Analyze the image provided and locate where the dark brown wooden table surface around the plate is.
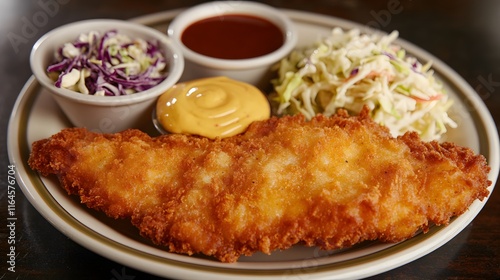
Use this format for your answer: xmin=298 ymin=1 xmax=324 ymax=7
xmin=0 ymin=0 xmax=500 ymax=279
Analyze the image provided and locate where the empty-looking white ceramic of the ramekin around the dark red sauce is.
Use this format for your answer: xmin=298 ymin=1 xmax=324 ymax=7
xmin=167 ymin=1 xmax=298 ymax=88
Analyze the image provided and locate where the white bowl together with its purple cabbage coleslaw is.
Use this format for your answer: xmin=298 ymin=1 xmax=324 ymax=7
xmin=30 ymin=19 xmax=184 ymax=133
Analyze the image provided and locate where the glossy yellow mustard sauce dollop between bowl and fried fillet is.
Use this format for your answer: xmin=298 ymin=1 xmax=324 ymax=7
xmin=156 ymin=77 xmax=271 ymax=139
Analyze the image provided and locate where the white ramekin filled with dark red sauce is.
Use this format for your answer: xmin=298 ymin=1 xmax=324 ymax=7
xmin=167 ymin=1 xmax=297 ymax=88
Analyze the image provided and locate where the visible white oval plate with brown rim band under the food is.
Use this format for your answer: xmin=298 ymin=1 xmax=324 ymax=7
xmin=8 ymin=10 xmax=500 ymax=279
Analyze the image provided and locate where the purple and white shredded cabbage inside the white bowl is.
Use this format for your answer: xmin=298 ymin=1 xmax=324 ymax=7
xmin=47 ymin=30 xmax=168 ymax=96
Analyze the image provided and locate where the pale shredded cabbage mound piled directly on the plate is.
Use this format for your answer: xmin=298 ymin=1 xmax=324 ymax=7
xmin=272 ymin=28 xmax=457 ymax=141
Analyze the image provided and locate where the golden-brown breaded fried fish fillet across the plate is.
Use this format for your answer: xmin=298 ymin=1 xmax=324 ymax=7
xmin=29 ymin=110 xmax=491 ymax=262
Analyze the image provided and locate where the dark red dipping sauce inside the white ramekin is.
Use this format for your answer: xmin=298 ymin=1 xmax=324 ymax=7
xmin=181 ymin=14 xmax=284 ymax=59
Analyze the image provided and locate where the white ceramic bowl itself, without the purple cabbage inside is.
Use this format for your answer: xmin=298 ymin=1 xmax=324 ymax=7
xmin=30 ymin=19 xmax=184 ymax=133
